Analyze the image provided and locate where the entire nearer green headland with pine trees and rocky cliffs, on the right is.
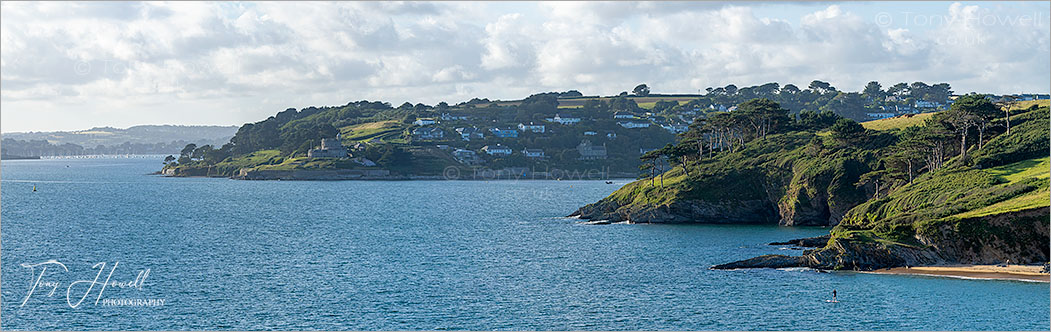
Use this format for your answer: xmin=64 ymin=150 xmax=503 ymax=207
xmin=574 ymin=96 xmax=1051 ymax=269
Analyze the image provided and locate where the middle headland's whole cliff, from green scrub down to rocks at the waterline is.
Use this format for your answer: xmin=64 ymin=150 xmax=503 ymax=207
xmin=571 ymin=134 xmax=873 ymax=226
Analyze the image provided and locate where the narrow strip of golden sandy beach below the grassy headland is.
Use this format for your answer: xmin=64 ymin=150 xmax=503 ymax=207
xmin=872 ymin=265 xmax=1051 ymax=283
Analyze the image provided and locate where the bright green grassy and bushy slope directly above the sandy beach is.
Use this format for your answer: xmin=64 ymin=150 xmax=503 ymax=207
xmin=832 ymin=107 xmax=1051 ymax=243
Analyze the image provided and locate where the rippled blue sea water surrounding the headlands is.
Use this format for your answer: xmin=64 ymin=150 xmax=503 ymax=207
xmin=0 ymin=159 xmax=1051 ymax=330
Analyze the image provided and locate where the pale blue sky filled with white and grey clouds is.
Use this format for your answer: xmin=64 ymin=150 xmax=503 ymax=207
xmin=0 ymin=1 xmax=1051 ymax=132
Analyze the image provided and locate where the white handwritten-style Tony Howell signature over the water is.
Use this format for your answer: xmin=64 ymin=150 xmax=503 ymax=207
xmin=19 ymin=260 xmax=149 ymax=309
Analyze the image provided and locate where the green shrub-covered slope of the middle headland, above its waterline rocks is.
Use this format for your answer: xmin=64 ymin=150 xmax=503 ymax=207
xmin=592 ymin=131 xmax=874 ymax=220
